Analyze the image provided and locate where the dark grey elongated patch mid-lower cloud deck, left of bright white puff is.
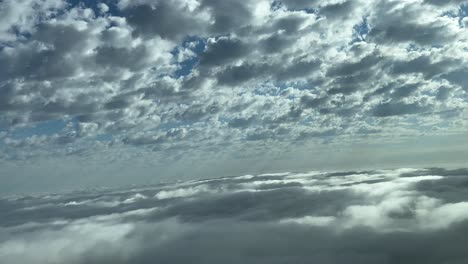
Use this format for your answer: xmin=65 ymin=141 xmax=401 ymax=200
xmin=154 ymin=188 xmax=359 ymax=222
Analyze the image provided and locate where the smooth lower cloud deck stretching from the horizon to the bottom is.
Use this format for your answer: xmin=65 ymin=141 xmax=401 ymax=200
xmin=0 ymin=168 xmax=468 ymax=264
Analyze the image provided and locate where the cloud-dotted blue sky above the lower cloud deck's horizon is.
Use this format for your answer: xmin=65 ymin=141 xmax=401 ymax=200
xmin=0 ymin=0 xmax=468 ymax=193
